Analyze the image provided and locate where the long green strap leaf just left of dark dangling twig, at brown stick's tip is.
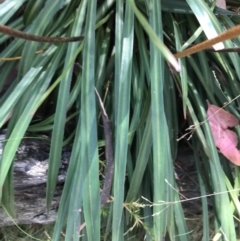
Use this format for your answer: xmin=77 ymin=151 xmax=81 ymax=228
xmin=80 ymin=0 xmax=100 ymax=241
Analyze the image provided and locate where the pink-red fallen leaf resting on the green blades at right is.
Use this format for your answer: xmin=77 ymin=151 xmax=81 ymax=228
xmin=207 ymin=102 xmax=240 ymax=166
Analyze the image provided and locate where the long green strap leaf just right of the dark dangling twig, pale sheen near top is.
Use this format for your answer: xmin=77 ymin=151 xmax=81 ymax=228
xmin=112 ymin=2 xmax=134 ymax=241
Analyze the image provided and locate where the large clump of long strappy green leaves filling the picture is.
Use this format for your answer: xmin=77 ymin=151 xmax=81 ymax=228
xmin=0 ymin=0 xmax=240 ymax=241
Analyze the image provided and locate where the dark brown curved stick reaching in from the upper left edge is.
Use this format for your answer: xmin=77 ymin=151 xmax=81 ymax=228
xmin=0 ymin=25 xmax=84 ymax=43
